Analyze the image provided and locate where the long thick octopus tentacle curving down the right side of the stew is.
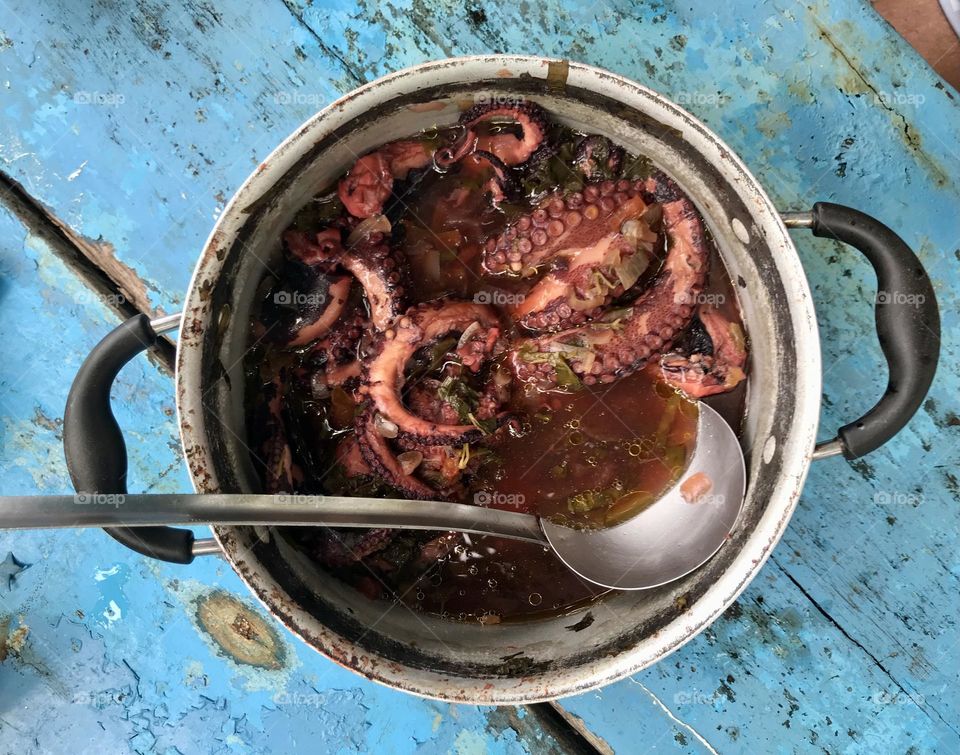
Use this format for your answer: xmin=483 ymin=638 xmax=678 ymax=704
xmin=511 ymin=193 xmax=709 ymax=390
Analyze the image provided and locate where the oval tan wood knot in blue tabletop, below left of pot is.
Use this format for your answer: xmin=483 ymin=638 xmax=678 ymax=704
xmin=196 ymin=592 xmax=286 ymax=670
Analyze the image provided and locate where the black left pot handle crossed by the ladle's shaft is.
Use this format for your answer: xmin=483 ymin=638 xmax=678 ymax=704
xmin=63 ymin=314 xmax=219 ymax=564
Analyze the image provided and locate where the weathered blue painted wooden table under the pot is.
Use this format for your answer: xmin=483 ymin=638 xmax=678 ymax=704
xmin=0 ymin=0 xmax=960 ymax=754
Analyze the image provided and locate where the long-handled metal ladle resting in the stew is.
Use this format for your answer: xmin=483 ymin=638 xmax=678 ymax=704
xmin=0 ymin=402 xmax=746 ymax=590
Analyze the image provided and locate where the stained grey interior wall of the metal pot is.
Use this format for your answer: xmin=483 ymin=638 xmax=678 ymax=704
xmin=193 ymin=71 xmax=796 ymax=697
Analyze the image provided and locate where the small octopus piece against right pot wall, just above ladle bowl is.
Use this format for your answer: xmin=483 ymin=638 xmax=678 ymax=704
xmin=660 ymin=306 xmax=747 ymax=398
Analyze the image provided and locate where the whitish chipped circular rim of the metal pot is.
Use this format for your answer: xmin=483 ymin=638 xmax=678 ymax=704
xmin=175 ymin=55 xmax=822 ymax=704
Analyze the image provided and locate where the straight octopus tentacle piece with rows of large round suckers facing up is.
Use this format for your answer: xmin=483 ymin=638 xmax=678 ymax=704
xmin=483 ymin=179 xmax=648 ymax=275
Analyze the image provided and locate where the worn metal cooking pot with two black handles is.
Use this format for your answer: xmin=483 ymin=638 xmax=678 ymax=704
xmin=64 ymin=55 xmax=939 ymax=704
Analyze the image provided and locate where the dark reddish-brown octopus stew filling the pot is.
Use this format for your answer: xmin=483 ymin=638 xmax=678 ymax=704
xmin=246 ymin=102 xmax=747 ymax=624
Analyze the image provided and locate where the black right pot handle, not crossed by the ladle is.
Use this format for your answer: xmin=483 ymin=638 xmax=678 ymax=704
xmin=783 ymin=202 xmax=940 ymax=461
